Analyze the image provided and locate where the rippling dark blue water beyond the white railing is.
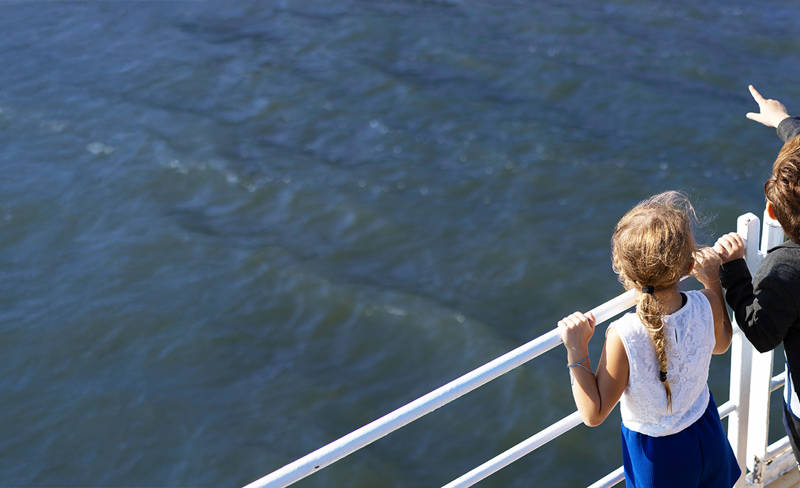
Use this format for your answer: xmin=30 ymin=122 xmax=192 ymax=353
xmin=0 ymin=0 xmax=800 ymax=487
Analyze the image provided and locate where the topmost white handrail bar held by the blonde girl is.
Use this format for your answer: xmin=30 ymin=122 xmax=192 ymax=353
xmin=245 ymin=290 xmax=636 ymax=488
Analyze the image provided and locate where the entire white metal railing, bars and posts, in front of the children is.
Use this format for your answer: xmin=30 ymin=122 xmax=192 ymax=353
xmin=245 ymin=212 xmax=793 ymax=488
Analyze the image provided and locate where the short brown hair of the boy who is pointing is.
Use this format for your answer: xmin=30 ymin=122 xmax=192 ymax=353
xmin=764 ymin=136 xmax=800 ymax=243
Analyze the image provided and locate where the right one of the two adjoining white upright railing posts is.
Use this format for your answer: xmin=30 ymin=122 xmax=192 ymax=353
xmin=747 ymin=211 xmax=784 ymax=487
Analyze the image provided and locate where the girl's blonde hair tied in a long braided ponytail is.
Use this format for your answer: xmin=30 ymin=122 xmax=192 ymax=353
xmin=611 ymin=191 xmax=696 ymax=411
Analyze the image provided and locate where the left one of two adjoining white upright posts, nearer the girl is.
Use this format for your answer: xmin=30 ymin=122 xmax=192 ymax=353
xmin=728 ymin=213 xmax=761 ymax=488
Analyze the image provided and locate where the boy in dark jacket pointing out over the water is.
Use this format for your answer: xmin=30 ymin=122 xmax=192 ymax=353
xmin=714 ymin=85 xmax=800 ymax=462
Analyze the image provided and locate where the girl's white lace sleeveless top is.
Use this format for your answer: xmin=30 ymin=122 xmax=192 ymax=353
xmin=612 ymin=291 xmax=716 ymax=437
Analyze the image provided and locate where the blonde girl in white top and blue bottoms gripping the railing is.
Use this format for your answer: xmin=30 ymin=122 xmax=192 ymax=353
xmin=558 ymin=192 xmax=741 ymax=488
